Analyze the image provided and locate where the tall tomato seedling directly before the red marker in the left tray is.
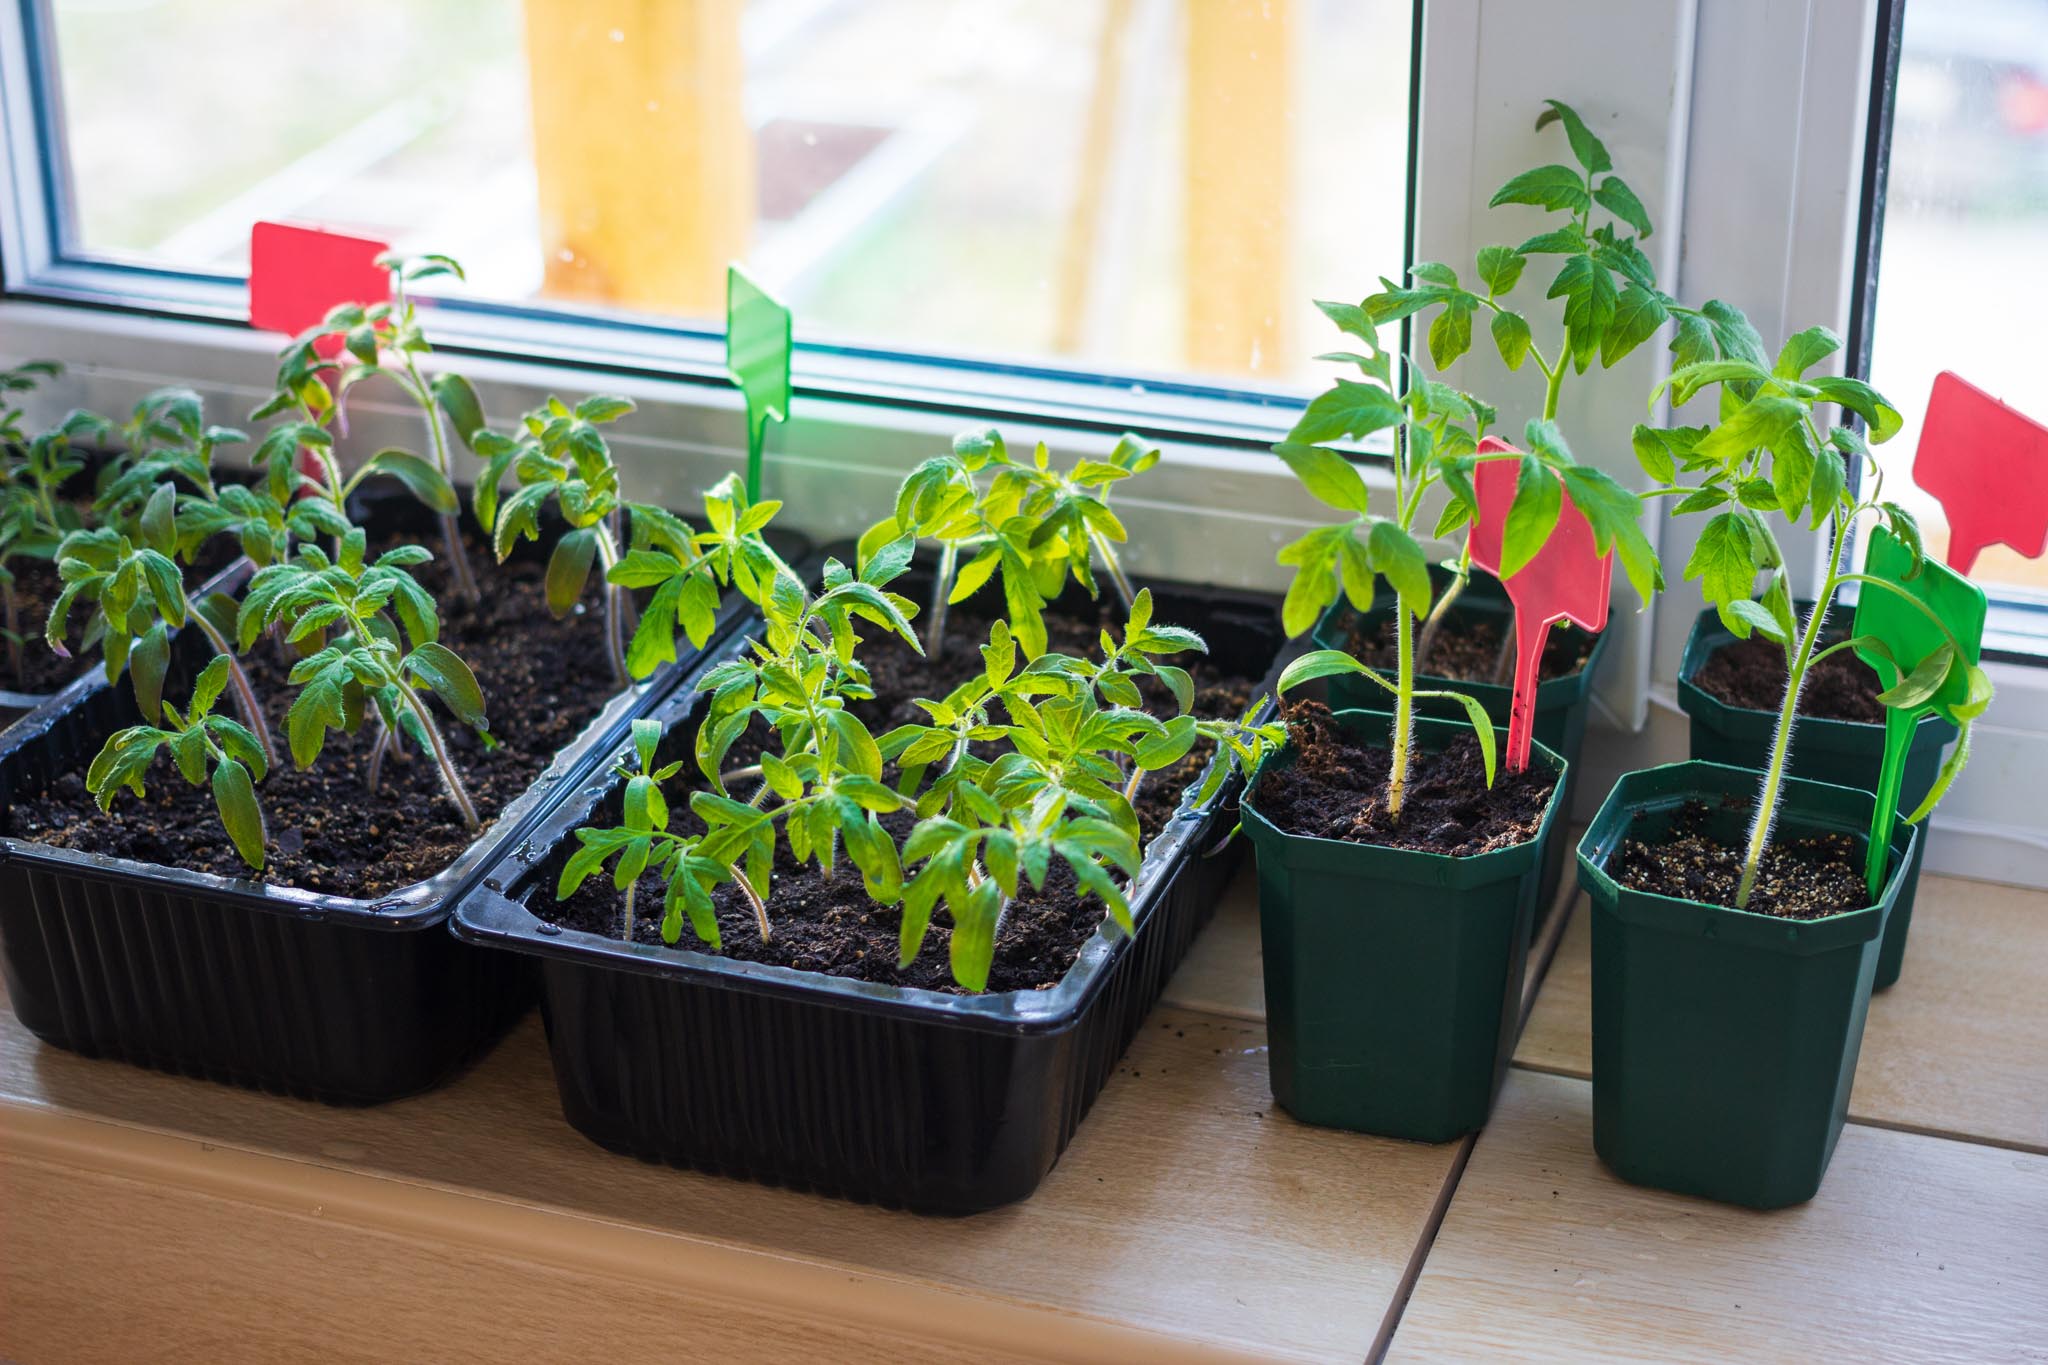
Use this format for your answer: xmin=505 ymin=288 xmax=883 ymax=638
xmin=252 ymin=256 xmax=483 ymax=604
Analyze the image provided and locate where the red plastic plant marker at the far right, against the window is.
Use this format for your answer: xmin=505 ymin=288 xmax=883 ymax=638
xmin=1913 ymin=370 xmax=2048 ymax=573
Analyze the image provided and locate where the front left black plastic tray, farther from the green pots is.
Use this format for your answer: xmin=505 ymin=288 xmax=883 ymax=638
xmin=0 ymin=509 xmax=793 ymax=1105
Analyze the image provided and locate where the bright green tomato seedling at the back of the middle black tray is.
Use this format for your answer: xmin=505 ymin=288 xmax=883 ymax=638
xmin=860 ymin=428 xmax=1159 ymax=659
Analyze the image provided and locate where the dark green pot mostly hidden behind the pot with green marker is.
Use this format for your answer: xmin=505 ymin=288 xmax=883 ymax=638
xmin=1677 ymin=602 xmax=1956 ymax=990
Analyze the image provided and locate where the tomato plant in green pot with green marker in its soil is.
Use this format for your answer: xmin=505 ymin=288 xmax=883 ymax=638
xmin=1579 ymin=317 xmax=1991 ymax=1207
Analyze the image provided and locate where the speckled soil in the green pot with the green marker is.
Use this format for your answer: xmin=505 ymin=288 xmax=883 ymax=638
xmin=1608 ymin=800 xmax=1870 ymax=919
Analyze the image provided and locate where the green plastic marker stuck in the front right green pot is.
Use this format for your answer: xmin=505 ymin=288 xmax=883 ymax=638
xmin=1853 ymin=526 xmax=1985 ymax=896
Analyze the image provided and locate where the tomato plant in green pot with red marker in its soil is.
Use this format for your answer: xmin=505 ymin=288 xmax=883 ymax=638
xmin=1245 ymin=258 xmax=1659 ymax=1140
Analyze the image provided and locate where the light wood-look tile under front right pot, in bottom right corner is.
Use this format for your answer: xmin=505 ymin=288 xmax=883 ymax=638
xmin=1386 ymin=1070 xmax=2048 ymax=1365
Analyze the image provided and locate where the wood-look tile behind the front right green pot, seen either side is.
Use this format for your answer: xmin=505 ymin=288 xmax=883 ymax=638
xmin=1516 ymin=876 xmax=2048 ymax=1152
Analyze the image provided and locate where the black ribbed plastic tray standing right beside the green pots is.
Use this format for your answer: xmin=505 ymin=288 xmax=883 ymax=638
xmin=451 ymin=568 xmax=1284 ymax=1214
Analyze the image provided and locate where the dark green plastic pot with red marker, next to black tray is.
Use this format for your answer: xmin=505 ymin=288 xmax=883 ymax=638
xmin=1243 ymin=710 xmax=1567 ymax=1142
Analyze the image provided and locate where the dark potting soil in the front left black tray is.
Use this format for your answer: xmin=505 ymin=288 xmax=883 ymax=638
xmin=6 ymin=523 xmax=616 ymax=898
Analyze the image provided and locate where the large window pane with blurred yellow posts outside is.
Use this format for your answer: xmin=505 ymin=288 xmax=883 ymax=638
xmin=39 ymin=0 xmax=1413 ymax=387
